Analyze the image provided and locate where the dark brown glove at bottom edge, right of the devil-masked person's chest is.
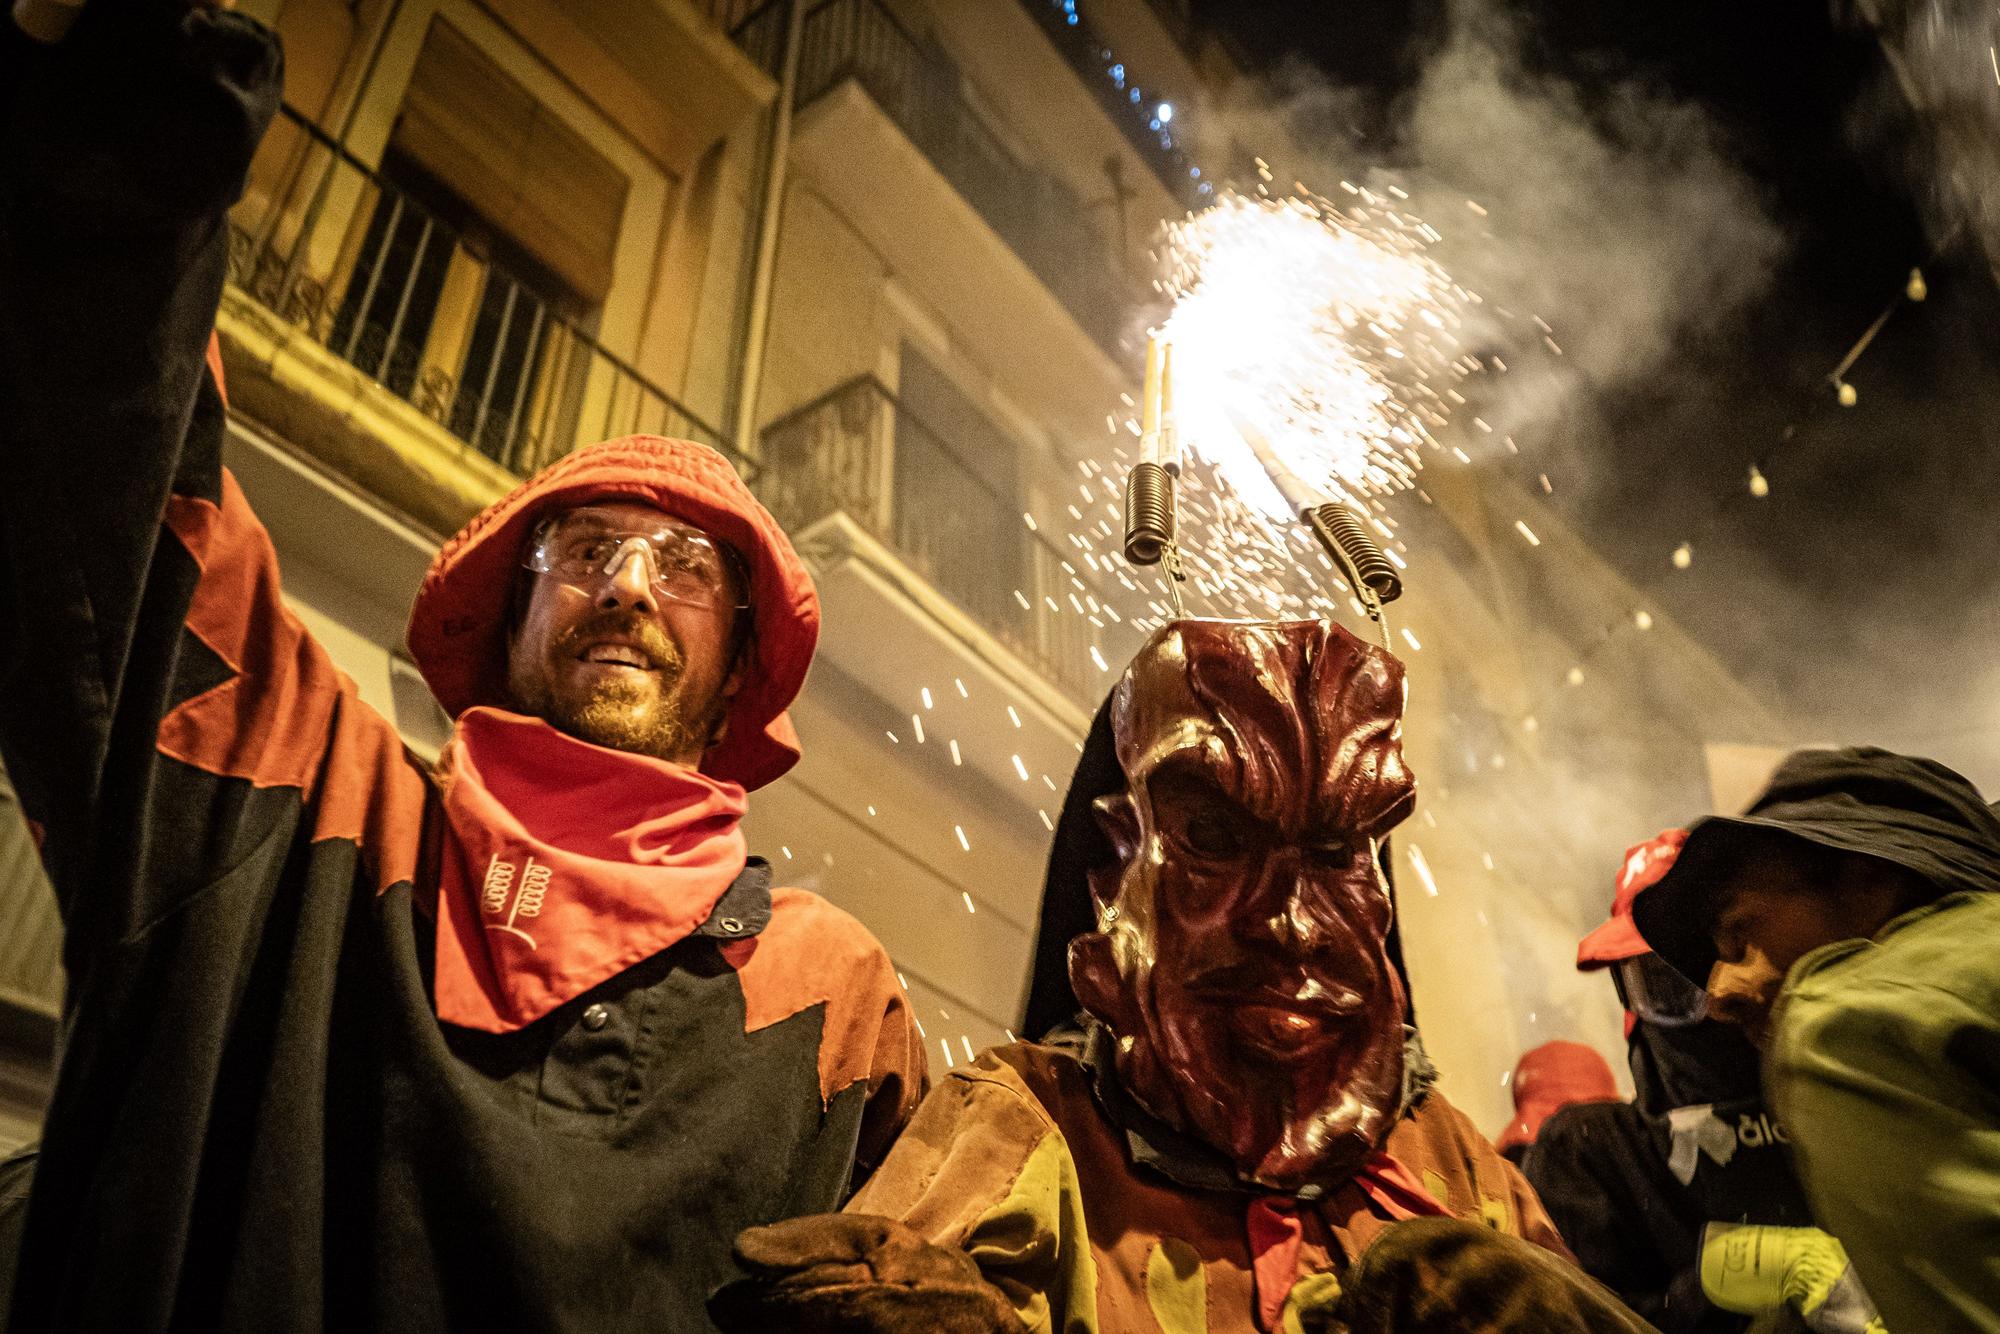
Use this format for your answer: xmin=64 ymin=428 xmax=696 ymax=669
xmin=1336 ymin=1218 xmax=1658 ymax=1334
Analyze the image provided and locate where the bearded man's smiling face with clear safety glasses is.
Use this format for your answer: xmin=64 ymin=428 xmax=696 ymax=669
xmin=508 ymin=500 xmax=744 ymax=766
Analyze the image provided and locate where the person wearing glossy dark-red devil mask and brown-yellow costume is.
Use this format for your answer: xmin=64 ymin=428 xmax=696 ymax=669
xmin=714 ymin=620 xmax=1646 ymax=1334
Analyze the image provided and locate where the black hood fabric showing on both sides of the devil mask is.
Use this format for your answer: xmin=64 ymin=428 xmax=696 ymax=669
xmin=1020 ymin=686 xmax=1416 ymax=1040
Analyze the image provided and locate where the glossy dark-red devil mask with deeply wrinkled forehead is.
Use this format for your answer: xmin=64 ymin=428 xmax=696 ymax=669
xmin=1070 ymin=620 xmax=1416 ymax=1190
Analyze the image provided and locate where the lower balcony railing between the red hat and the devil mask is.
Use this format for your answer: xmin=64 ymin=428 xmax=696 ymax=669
xmin=758 ymin=376 xmax=1106 ymax=708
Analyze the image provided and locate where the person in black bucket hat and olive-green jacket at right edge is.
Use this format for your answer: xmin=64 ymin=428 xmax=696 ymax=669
xmin=1632 ymin=746 xmax=2000 ymax=1334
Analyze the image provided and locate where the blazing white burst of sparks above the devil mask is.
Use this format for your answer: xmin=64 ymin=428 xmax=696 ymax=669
xmin=1162 ymin=188 xmax=1478 ymax=518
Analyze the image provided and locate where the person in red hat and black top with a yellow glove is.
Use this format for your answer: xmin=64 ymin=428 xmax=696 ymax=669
xmin=1522 ymin=830 xmax=1880 ymax=1334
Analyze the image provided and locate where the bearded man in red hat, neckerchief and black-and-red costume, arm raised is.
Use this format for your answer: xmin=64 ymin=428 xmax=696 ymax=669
xmin=0 ymin=0 xmax=922 ymax=1334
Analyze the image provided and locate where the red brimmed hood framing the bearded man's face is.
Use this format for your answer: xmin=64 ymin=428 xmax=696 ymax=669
xmin=410 ymin=436 xmax=820 ymax=788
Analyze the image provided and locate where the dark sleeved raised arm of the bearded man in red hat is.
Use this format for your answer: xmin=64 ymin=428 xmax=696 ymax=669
xmin=0 ymin=0 xmax=280 ymax=934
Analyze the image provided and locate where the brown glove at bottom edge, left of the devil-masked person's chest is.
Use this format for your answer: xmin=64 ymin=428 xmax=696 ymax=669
xmin=708 ymin=1214 xmax=1022 ymax=1334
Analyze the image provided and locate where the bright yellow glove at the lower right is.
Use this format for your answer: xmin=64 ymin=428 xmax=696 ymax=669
xmin=1702 ymin=1222 xmax=1884 ymax=1334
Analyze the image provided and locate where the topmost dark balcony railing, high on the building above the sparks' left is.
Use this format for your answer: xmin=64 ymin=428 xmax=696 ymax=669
xmin=798 ymin=0 xmax=1130 ymax=354
